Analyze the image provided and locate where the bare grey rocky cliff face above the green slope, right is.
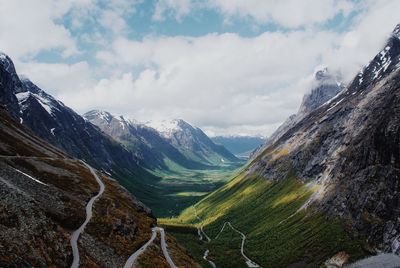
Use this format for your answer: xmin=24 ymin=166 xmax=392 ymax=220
xmin=248 ymin=24 xmax=400 ymax=252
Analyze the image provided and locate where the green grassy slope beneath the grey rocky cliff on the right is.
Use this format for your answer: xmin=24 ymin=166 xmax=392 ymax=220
xmin=161 ymin=174 xmax=364 ymax=267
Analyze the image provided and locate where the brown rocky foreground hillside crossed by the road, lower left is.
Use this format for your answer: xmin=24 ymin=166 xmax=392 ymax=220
xmin=0 ymin=105 xmax=195 ymax=267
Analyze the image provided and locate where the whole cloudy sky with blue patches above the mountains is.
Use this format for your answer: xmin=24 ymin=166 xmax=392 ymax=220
xmin=0 ymin=0 xmax=400 ymax=136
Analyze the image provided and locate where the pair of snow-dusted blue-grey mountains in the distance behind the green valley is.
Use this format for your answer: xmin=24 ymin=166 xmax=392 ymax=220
xmin=84 ymin=110 xmax=237 ymax=169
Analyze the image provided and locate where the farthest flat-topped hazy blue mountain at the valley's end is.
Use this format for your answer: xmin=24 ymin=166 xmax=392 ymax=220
xmin=211 ymin=136 xmax=266 ymax=157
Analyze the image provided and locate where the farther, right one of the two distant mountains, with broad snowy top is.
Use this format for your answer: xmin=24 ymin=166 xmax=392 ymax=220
xmin=146 ymin=119 xmax=238 ymax=165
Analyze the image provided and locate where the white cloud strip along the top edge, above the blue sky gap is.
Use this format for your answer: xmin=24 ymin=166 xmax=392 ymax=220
xmin=153 ymin=0 xmax=355 ymax=28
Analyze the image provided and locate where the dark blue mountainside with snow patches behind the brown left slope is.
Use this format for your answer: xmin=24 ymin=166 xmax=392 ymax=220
xmin=0 ymin=54 xmax=164 ymax=205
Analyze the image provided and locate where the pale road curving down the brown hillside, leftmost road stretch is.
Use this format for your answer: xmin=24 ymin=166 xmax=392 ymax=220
xmin=71 ymin=161 xmax=105 ymax=268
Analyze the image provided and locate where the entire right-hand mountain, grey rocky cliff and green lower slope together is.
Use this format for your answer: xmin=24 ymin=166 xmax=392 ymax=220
xmin=170 ymin=25 xmax=400 ymax=267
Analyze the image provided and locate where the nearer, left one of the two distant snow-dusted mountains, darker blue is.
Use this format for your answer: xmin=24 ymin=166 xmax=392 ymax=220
xmin=84 ymin=110 xmax=207 ymax=170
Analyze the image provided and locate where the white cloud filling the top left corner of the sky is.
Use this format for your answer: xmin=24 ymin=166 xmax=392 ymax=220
xmin=0 ymin=0 xmax=88 ymax=57
